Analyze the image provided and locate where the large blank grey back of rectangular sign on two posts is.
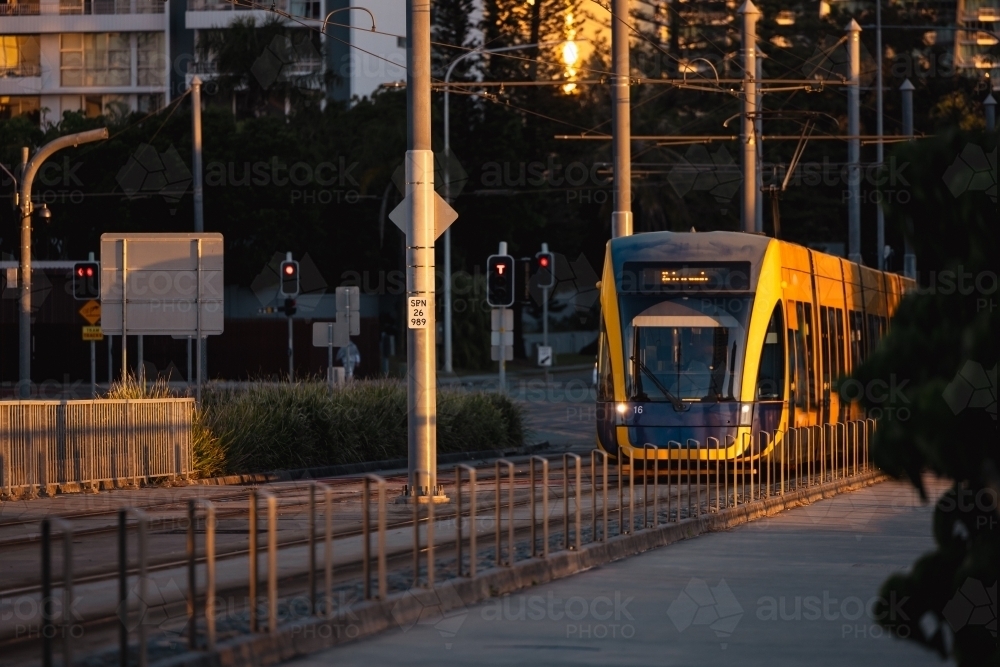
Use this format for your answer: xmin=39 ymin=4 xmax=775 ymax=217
xmin=101 ymin=233 xmax=224 ymax=338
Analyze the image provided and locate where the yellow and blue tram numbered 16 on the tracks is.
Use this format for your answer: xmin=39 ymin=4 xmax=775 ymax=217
xmin=597 ymin=232 xmax=913 ymax=465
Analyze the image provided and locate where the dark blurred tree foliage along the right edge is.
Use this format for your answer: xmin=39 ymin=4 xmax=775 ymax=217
xmin=856 ymin=131 xmax=1000 ymax=666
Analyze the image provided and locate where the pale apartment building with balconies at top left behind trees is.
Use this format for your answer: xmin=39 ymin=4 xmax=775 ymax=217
xmin=0 ymin=0 xmax=406 ymax=123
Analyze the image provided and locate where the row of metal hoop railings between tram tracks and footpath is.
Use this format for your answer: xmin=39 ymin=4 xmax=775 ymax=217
xmin=29 ymin=420 xmax=876 ymax=667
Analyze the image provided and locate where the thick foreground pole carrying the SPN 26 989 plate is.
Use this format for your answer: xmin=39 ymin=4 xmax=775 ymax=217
xmin=405 ymin=0 xmax=438 ymax=502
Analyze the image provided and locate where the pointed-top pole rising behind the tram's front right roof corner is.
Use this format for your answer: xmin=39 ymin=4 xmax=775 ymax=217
xmin=738 ymin=0 xmax=760 ymax=232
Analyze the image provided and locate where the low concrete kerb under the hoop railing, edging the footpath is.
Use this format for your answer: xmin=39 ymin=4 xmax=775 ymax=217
xmin=153 ymin=472 xmax=890 ymax=667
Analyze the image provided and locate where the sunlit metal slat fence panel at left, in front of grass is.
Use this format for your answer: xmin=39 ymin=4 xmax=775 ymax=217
xmin=0 ymin=398 xmax=194 ymax=496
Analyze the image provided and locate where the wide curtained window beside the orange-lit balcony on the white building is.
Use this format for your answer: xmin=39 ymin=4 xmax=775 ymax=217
xmin=59 ymin=32 xmax=132 ymax=87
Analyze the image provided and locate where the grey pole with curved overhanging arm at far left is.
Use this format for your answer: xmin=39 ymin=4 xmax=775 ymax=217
xmin=17 ymin=127 xmax=108 ymax=398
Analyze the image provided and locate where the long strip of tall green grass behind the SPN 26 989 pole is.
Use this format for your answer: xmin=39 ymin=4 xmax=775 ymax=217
xmin=108 ymin=379 xmax=525 ymax=476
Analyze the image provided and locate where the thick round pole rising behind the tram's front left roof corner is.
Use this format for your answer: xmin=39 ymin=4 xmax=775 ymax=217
xmin=611 ymin=0 xmax=632 ymax=238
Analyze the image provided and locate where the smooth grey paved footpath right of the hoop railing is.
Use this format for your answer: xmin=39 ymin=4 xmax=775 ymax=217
xmin=289 ymin=482 xmax=942 ymax=667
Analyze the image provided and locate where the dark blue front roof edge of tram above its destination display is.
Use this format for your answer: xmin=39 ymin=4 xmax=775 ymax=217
xmin=611 ymin=232 xmax=774 ymax=276
